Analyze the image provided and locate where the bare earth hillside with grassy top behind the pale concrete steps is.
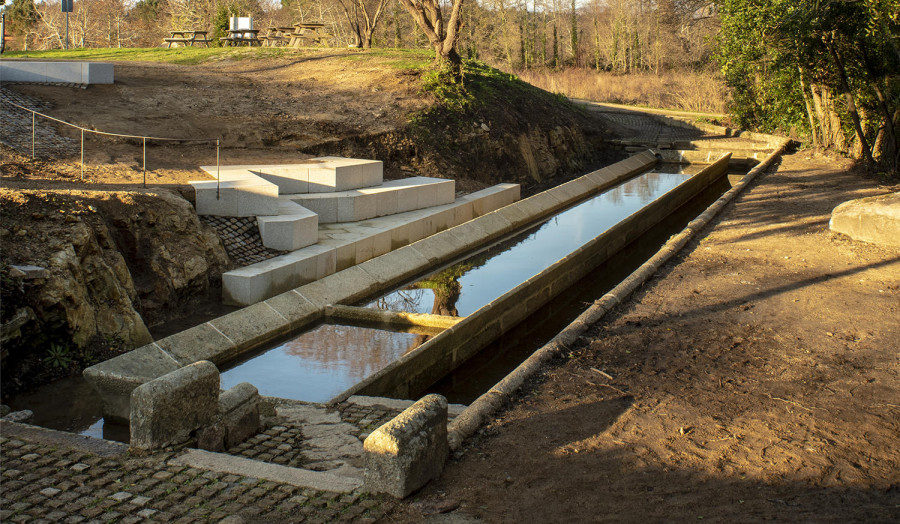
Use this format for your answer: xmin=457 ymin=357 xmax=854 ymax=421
xmin=4 ymin=49 xmax=609 ymax=190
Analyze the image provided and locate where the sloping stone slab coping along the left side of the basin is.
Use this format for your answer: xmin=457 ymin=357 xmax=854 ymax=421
xmin=84 ymin=155 xmax=657 ymax=416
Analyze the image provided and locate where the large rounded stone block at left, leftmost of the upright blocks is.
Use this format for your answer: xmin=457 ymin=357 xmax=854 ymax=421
xmin=130 ymin=360 xmax=219 ymax=451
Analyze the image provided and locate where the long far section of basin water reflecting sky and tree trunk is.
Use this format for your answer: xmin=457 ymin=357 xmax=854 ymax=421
xmin=367 ymin=173 xmax=689 ymax=316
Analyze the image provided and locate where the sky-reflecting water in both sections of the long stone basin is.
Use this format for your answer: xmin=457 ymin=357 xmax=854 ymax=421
xmin=221 ymin=168 xmax=704 ymax=402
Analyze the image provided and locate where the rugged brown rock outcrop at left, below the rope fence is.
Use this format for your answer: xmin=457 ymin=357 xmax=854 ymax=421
xmin=0 ymin=189 xmax=229 ymax=396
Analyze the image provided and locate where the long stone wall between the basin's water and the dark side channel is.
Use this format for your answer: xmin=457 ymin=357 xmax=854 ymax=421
xmin=330 ymin=155 xmax=730 ymax=403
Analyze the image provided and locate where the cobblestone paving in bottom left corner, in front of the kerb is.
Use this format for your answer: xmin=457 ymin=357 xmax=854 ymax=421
xmin=0 ymin=423 xmax=394 ymax=524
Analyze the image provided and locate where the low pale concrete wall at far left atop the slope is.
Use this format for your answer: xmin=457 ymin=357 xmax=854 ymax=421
xmin=0 ymin=60 xmax=114 ymax=84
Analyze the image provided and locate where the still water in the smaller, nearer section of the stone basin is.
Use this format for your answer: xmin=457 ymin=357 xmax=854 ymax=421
xmin=222 ymin=324 xmax=436 ymax=402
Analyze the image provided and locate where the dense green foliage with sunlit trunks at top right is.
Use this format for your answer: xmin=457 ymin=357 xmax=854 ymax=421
xmin=716 ymin=0 xmax=900 ymax=173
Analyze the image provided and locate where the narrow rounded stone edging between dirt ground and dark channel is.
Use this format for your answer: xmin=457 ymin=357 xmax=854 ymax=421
xmin=448 ymin=138 xmax=791 ymax=451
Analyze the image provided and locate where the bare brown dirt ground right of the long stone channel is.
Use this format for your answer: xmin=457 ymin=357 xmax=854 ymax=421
xmin=391 ymin=151 xmax=900 ymax=522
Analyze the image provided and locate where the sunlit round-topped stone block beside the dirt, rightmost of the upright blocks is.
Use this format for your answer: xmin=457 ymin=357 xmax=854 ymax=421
xmin=363 ymin=395 xmax=450 ymax=498
